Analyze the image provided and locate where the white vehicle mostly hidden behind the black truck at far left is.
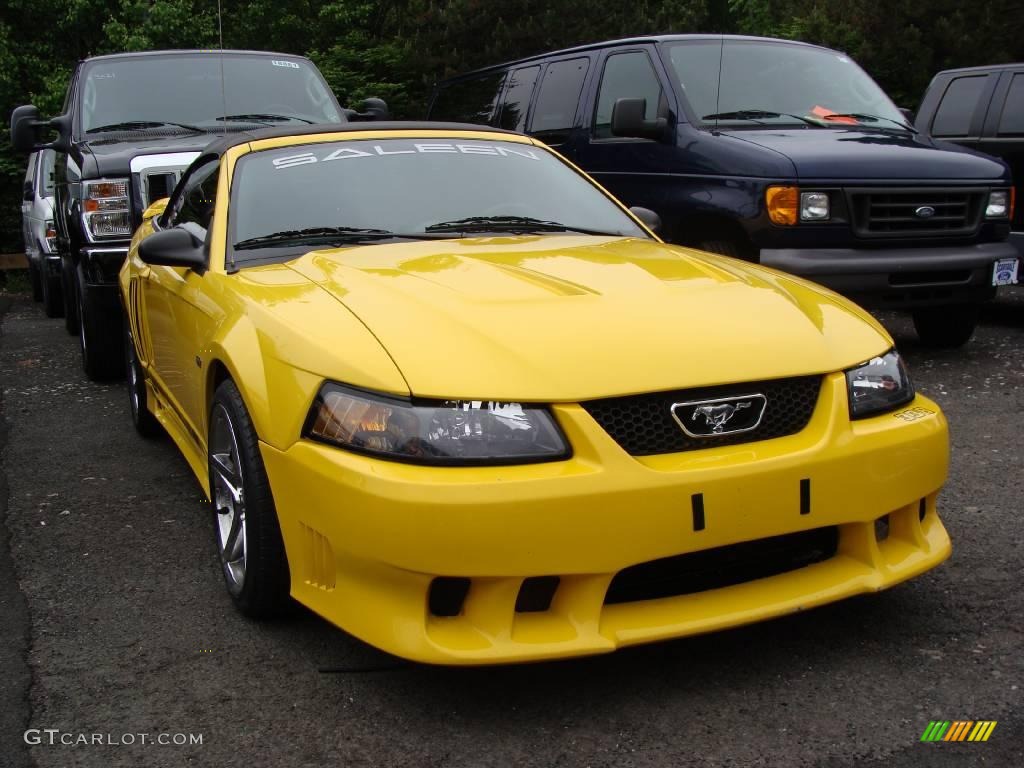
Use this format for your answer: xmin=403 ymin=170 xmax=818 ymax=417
xmin=22 ymin=150 xmax=63 ymax=317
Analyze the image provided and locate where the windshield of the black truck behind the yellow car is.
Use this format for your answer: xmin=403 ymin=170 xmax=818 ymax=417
xmin=79 ymin=52 xmax=341 ymax=133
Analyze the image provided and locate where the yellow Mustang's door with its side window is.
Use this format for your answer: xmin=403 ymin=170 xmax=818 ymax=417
xmin=142 ymin=158 xmax=219 ymax=438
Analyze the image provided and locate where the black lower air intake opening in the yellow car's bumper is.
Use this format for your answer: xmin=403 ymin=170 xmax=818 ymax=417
xmin=604 ymin=525 xmax=839 ymax=605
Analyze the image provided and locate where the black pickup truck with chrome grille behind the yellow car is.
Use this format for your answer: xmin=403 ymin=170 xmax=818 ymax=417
xmin=11 ymin=50 xmax=383 ymax=379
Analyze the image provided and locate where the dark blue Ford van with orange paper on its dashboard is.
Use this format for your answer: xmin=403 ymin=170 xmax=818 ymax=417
xmin=430 ymin=35 xmax=1017 ymax=346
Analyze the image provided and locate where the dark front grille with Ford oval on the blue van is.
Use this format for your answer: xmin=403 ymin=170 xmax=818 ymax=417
xmin=847 ymin=187 xmax=987 ymax=238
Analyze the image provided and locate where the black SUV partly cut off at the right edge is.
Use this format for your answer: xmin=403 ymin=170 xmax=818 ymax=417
xmin=914 ymin=63 xmax=1024 ymax=256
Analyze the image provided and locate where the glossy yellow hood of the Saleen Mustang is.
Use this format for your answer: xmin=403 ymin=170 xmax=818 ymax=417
xmin=289 ymin=236 xmax=892 ymax=401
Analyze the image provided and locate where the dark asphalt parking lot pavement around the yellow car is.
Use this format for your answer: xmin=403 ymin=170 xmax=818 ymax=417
xmin=0 ymin=289 xmax=1024 ymax=768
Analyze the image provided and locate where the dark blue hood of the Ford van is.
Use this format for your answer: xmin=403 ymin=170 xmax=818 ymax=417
xmin=723 ymin=128 xmax=1009 ymax=183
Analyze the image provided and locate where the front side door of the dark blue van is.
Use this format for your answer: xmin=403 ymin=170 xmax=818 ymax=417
xmin=575 ymin=46 xmax=677 ymax=217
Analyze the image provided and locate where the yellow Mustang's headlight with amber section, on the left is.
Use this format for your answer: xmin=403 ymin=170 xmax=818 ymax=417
xmin=303 ymin=382 xmax=569 ymax=465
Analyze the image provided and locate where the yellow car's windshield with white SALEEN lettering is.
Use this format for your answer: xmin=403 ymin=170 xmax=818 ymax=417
xmin=230 ymin=138 xmax=647 ymax=262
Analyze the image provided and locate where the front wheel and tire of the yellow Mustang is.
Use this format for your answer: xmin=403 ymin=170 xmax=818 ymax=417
xmin=207 ymin=379 xmax=292 ymax=618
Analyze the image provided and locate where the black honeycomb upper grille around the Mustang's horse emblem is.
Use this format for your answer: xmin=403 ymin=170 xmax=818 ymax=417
xmin=582 ymin=376 xmax=821 ymax=456
